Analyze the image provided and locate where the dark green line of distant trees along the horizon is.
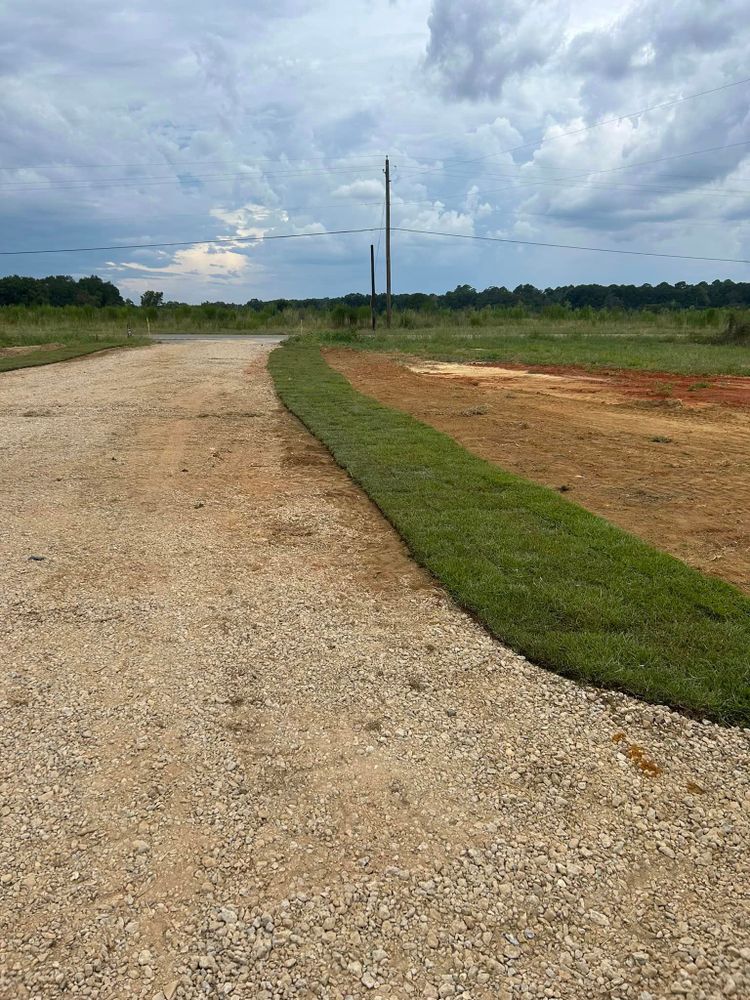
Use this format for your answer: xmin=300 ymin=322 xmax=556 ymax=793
xmin=0 ymin=274 xmax=750 ymax=313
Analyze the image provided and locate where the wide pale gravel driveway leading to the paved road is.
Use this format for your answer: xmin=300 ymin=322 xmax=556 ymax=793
xmin=0 ymin=342 xmax=750 ymax=1000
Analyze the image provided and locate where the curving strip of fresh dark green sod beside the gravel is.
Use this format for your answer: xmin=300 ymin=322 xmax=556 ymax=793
xmin=270 ymin=342 xmax=750 ymax=725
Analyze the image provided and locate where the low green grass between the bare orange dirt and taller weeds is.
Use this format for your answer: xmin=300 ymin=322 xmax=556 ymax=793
xmin=316 ymin=318 xmax=750 ymax=375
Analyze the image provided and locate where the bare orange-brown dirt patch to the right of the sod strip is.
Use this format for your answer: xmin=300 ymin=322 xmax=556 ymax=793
xmin=326 ymin=350 xmax=750 ymax=591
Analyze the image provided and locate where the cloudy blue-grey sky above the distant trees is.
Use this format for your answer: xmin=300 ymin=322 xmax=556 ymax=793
xmin=0 ymin=0 xmax=750 ymax=302
